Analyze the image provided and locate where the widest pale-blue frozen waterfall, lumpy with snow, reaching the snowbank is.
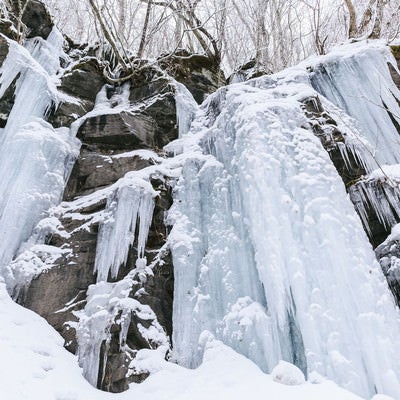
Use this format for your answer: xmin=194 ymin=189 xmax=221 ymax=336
xmin=170 ymin=51 xmax=400 ymax=398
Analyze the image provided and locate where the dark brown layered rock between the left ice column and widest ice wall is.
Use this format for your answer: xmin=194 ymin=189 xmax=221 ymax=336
xmin=18 ymin=66 xmax=177 ymax=392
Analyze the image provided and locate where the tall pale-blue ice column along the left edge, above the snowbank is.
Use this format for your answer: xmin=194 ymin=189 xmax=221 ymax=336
xmin=0 ymin=29 xmax=78 ymax=269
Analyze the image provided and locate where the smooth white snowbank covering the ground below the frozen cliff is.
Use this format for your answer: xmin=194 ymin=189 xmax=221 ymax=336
xmin=0 ymin=282 xmax=366 ymax=400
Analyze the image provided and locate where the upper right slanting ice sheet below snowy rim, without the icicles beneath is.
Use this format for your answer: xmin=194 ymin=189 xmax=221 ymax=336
xmin=311 ymin=44 xmax=400 ymax=164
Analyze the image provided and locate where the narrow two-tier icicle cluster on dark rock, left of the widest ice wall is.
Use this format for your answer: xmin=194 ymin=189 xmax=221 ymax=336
xmin=71 ymin=172 xmax=160 ymax=386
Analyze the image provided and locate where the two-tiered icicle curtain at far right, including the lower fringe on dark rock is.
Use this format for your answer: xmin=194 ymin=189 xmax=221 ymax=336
xmin=311 ymin=45 xmax=400 ymax=244
